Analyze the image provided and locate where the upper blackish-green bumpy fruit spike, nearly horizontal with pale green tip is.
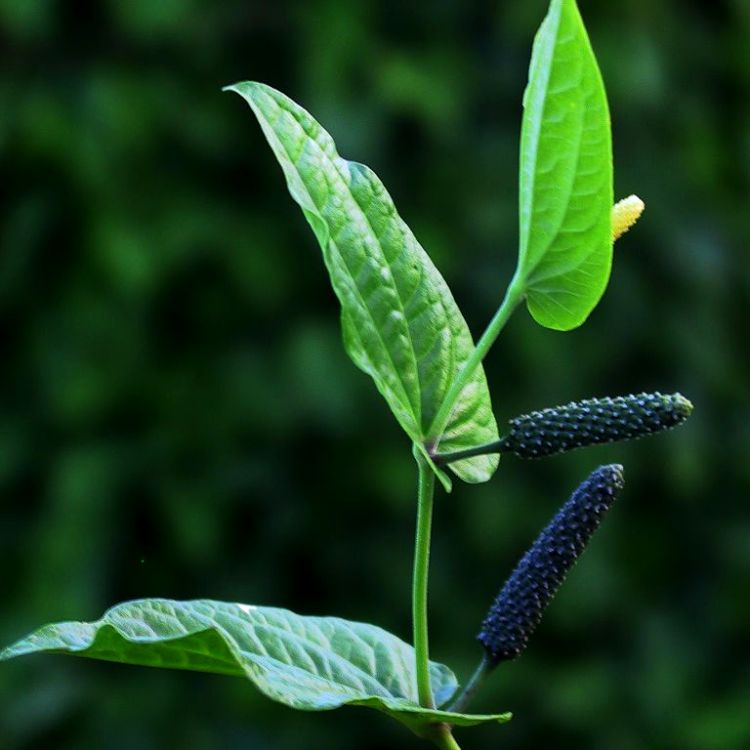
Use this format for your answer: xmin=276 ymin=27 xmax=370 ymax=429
xmin=497 ymin=392 xmax=693 ymax=458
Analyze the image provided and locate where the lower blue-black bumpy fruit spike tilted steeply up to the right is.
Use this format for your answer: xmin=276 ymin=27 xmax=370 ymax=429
xmin=477 ymin=464 xmax=624 ymax=666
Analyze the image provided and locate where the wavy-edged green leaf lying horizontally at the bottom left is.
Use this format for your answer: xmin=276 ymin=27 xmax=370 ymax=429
xmin=0 ymin=599 xmax=510 ymax=734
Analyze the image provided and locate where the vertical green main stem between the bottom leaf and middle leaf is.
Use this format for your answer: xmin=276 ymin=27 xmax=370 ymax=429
xmin=412 ymin=451 xmax=435 ymax=708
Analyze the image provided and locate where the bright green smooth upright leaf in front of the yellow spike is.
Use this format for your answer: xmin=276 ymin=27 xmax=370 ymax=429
xmin=517 ymin=0 xmax=613 ymax=330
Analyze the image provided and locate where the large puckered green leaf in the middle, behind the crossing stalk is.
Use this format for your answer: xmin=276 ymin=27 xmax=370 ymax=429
xmin=228 ymin=82 xmax=497 ymax=482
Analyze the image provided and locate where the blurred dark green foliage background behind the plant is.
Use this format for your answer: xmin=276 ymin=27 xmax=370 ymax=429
xmin=0 ymin=0 xmax=750 ymax=750
